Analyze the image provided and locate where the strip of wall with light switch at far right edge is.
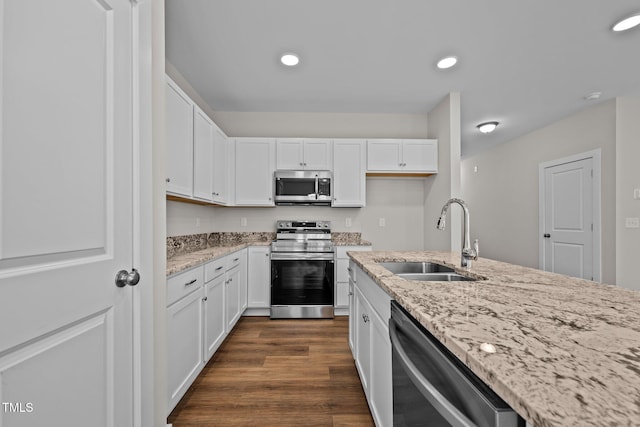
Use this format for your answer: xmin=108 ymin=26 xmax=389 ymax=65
xmin=615 ymin=98 xmax=640 ymax=290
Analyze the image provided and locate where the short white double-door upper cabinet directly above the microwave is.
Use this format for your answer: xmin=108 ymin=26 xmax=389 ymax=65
xmin=276 ymin=138 xmax=332 ymax=170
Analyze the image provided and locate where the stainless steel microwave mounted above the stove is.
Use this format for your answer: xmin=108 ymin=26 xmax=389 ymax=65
xmin=273 ymin=170 xmax=333 ymax=206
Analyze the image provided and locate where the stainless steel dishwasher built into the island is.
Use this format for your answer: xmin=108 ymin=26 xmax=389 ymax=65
xmin=389 ymin=301 xmax=525 ymax=427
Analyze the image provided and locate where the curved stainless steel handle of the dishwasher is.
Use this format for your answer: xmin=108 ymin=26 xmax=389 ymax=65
xmin=389 ymin=319 xmax=477 ymax=427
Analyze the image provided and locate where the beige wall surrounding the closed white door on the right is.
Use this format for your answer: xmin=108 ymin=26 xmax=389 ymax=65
xmin=462 ymin=101 xmax=616 ymax=283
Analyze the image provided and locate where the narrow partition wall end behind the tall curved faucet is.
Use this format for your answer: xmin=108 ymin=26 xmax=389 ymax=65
xmin=424 ymin=93 xmax=462 ymax=252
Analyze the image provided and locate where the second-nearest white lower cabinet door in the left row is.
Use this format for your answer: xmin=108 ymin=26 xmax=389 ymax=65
xmin=204 ymin=274 xmax=226 ymax=363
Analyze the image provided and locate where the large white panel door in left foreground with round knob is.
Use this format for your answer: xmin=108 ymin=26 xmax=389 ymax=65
xmin=0 ymin=0 xmax=133 ymax=427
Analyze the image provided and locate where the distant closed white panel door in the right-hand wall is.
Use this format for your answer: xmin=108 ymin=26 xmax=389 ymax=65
xmin=543 ymin=158 xmax=593 ymax=280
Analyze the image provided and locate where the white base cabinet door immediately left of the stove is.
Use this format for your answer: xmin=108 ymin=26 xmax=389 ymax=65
xmin=247 ymin=246 xmax=271 ymax=308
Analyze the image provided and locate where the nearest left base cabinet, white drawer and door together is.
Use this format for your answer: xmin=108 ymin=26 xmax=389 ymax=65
xmin=166 ymin=266 xmax=204 ymax=411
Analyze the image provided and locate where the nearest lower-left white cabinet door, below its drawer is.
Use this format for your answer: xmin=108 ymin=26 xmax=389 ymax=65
xmin=167 ymin=288 xmax=204 ymax=412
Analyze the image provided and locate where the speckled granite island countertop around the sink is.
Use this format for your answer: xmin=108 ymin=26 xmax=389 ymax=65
xmin=349 ymin=251 xmax=640 ymax=427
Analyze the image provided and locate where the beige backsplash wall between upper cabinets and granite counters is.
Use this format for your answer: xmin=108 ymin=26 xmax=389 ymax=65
xmin=167 ymin=177 xmax=433 ymax=250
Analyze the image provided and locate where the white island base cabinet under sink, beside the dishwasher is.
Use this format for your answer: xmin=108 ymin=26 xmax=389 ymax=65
xmin=349 ymin=262 xmax=393 ymax=427
